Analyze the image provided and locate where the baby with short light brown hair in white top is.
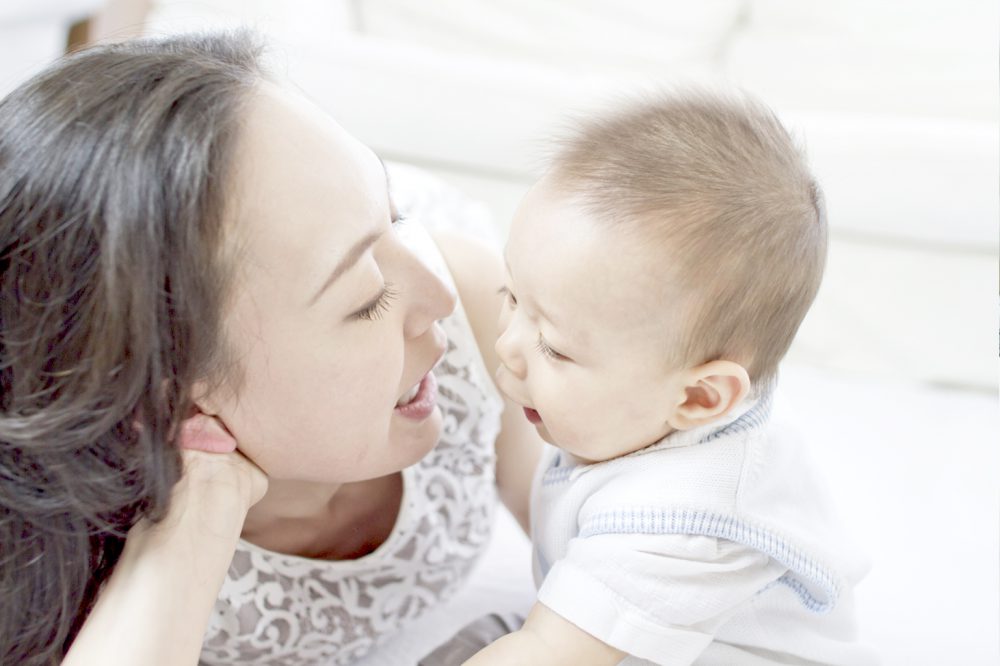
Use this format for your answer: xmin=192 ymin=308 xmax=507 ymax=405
xmin=466 ymin=93 xmax=872 ymax=666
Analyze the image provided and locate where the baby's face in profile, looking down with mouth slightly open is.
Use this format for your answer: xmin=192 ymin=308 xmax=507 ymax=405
xmin=496 ymin=179 xmax=685 ymax=462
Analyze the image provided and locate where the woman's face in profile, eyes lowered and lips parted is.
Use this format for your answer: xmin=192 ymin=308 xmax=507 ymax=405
xmin=207 ymin=84 xmax=455 ymax=483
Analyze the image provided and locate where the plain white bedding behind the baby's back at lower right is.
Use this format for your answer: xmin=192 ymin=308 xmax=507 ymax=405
xmin=783 ymin=361 xmax=1000 ymax=666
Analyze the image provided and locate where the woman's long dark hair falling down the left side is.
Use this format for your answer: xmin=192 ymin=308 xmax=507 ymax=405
xmin=0 ymin=33 xmax=261 ymax=664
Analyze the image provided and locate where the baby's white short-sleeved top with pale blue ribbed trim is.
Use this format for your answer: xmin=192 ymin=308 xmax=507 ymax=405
xmin=532 ymin=397 xmax=874 ymax=666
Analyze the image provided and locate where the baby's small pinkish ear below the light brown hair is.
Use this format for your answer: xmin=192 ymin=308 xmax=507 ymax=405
xmin=669 ymin=361 xmax=750 ymax=430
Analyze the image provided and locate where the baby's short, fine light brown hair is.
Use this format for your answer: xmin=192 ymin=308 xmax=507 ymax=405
xmin=550 ymin=91 xmax=827 ymax=388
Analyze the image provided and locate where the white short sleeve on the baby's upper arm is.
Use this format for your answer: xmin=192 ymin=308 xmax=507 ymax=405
xmin=538 ymin=534 xmax=786 ymax=665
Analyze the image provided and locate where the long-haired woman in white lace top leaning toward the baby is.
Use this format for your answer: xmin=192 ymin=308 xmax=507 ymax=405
xmin=0 ymin=29 xmax=537 ymax=664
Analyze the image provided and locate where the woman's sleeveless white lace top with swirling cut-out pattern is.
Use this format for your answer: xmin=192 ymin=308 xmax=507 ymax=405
xmin=201 ymin=215 xmax=502 ymax=666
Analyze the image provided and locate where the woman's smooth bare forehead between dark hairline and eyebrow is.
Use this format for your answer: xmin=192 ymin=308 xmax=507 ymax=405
xmin=230 ymin=84 xmax=388 ymax=292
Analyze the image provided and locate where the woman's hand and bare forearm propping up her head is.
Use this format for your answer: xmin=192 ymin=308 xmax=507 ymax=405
xmin=63 ymin=414 xmax=267 ymax=666
